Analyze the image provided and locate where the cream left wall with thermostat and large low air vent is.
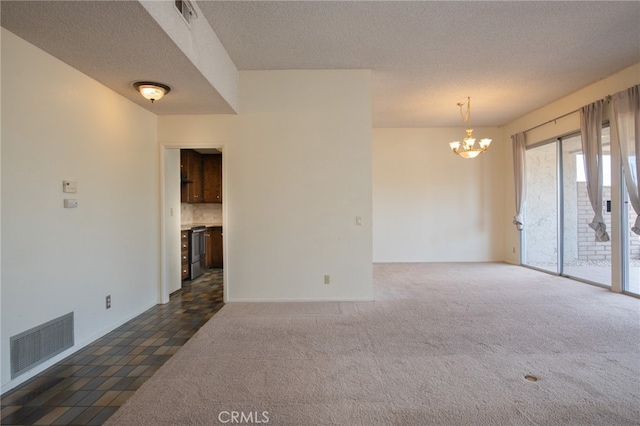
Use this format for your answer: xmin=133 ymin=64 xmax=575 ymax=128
xmin=0 ymin=29 xmax=159 ymax=392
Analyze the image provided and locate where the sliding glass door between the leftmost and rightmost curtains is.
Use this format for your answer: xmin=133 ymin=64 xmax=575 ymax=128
xmin=522 ymin=127 xmax=620 ymax=286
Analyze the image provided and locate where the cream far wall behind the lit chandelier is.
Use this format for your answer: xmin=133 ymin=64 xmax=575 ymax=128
xmin=373 ymin=128 xmax=505 ymax=262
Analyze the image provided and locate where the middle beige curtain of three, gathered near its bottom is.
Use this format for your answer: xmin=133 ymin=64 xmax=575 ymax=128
xmin=580 ymin=100 xmax=609 ymax=242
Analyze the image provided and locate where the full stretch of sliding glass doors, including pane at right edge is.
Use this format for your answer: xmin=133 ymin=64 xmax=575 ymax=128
xmin=521 ymin=126 xmax=640 ymax=296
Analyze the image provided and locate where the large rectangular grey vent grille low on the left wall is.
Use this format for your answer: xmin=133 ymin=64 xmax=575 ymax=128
xmin=9 ymin=312 xmax=73 ymax=379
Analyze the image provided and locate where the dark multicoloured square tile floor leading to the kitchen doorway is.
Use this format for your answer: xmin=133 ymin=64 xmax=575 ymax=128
xmin=0 ymin=269 xmax=223 ymax=426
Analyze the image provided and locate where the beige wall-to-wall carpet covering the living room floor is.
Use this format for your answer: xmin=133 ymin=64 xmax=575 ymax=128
xmin=108 ymin=263 xmax=640 ymax=425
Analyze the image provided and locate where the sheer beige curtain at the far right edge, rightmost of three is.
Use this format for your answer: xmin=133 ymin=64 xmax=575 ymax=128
xmin=611 ymin=85 xmax=640 ymax=235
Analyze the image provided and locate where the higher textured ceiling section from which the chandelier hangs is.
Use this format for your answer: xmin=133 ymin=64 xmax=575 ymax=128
xmin=198 ymin=1 xmax=640 ymax=127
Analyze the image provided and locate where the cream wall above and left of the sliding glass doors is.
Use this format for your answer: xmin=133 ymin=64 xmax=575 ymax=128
xmin=502 ymin=64 xmax=640 ymax=264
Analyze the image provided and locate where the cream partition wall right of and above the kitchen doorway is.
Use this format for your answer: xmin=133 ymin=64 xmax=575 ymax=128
xmin=159 ymin=70 xmax=372 ymax=301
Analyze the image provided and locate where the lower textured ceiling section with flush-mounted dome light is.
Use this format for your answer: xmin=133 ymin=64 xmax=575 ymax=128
xmin=0 ymin=0 xmax=233 ymax=114
